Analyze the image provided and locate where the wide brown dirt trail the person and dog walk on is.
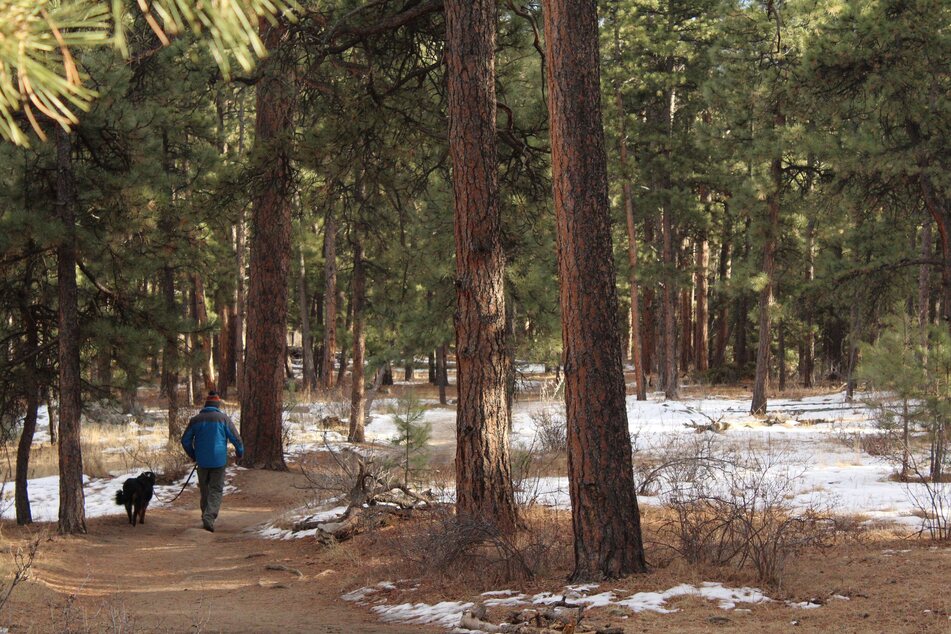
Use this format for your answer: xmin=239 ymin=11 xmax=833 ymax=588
xmin=0 ymin=462 xmax=437 ymax=633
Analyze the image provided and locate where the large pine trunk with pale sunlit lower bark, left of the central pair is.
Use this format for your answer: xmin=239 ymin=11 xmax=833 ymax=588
xmin=448 ymin=0 xmax=517 ymax=532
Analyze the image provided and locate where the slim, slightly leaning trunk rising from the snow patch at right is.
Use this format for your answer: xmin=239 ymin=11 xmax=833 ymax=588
xmin=750 ymin=143 xmax=783 ymax=415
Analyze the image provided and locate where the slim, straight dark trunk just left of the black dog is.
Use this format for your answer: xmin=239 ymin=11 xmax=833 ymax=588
xmin=56 ymin=127 xmax=86 ymax=534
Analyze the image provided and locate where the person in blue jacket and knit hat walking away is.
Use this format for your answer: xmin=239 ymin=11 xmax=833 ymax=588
xmin=182 ymin=390 xmax=244 ymax=533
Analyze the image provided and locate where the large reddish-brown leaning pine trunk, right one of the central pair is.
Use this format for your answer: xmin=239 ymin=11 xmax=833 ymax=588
xmin=543 ymin=0 xmax=646 ymax=582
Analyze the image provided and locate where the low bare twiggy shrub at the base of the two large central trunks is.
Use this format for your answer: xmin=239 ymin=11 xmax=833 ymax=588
xmin=395 ymin=507 xmax=572 ymax=587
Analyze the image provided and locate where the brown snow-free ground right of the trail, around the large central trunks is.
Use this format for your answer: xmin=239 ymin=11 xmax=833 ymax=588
xmin=332 ymin=514 xmax=951 ymax=634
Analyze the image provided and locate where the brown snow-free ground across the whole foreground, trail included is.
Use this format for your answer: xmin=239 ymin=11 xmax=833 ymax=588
xmin=0 ymin=454 xmax=951 ymax=634
